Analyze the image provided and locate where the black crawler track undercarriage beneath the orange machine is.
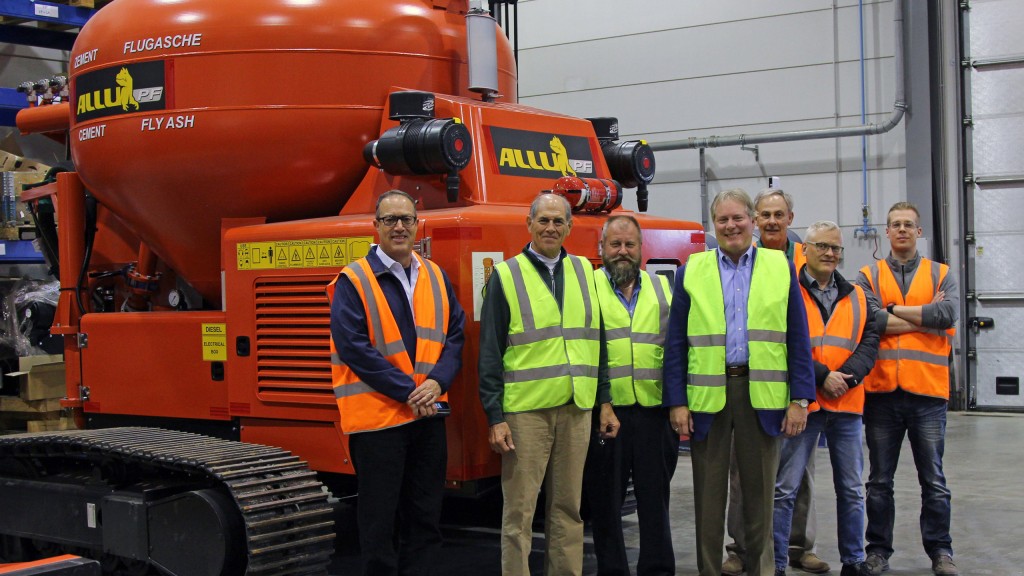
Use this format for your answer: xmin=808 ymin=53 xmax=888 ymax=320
xmin=0 ymin=428 xmax=334 ymax=576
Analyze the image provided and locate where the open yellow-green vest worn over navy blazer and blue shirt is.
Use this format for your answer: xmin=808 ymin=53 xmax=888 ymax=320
xmin=683 ymin=248 xmax=791 ymax=413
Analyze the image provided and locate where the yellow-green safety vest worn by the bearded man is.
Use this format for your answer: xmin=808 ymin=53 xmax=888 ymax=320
xmin=594 ymin=271 xmax=672 ymax=406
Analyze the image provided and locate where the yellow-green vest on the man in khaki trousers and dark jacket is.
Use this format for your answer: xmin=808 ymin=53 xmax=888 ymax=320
xmin=495 ymin=254 xmax=601 ymax=412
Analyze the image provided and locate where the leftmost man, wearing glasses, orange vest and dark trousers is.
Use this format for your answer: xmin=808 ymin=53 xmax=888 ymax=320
xmin=328 ymin=190 xmax=466 ymax=576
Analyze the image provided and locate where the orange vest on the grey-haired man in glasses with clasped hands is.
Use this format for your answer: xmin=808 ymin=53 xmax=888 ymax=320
xmin=800 ymin=284 xmax=874 ymax=414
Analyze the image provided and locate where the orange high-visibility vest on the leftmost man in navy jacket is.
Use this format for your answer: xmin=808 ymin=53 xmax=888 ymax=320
xmin=327 ymin=253 xmax=449 ymax=434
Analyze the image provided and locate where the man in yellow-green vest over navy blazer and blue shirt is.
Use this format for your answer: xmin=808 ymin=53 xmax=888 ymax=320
xmin=664 ymin=189 xmax=814 ymax=576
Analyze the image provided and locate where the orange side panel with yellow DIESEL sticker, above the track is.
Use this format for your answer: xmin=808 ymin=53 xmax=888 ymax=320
xmin=82 ymin=312 xmax=228 ymax=420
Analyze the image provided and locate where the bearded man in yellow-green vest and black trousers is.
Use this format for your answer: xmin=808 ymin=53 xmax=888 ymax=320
xmin=584 ymin=215 xmax=679 ymax=576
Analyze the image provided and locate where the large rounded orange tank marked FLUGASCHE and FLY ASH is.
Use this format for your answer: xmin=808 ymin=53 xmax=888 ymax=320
xmin=69 ymin=0 xmax=516 ymax=302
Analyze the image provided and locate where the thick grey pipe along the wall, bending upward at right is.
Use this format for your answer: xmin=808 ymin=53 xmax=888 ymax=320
xmin=650 ymin=0 xmax=907 ymax=152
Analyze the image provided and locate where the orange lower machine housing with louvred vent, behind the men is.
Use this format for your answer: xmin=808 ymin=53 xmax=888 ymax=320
xmin=221 ymin=203 xmax=703 ymax=485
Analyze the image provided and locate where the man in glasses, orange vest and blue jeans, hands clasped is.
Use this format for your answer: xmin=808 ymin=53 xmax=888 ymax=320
xmin=774 ymin=220 xmax=879 ymax=576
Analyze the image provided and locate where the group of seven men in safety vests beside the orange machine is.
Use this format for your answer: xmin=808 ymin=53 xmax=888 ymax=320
xmin=328 ymin=184 xmax=958 ymax=576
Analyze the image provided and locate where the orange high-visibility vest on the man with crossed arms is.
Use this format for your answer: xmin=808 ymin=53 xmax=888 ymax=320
xmin=861 ymin=258 xmax=956 ymax=400
